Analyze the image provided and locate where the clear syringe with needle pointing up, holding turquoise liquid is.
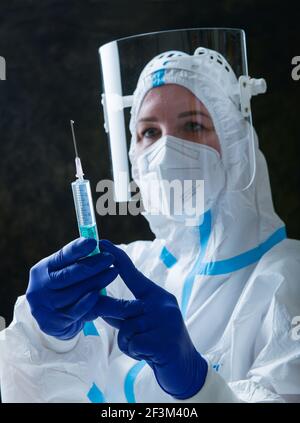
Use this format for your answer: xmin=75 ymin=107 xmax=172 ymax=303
xmin=70 ymin=120 xmax=100 ymax=256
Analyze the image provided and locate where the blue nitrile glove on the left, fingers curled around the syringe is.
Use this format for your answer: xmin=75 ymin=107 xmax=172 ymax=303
xmin=26 ymin=238 xmax=118 ymax=340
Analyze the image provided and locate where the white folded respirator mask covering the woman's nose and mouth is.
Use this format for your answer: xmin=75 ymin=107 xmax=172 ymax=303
xmin=135 ymin=135 xmax=225 ymax=225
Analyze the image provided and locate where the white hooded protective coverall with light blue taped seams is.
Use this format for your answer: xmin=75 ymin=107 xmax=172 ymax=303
xmin=0 ymin=48 xmax=300 ymax=403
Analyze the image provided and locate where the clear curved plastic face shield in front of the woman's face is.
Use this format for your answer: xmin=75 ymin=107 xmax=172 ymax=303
xmin=99 ymin=28 xmax=266 ymax=217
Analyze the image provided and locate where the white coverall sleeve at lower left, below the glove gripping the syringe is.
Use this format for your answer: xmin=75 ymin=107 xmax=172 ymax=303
xmin=0 ymin=296 xmax=114 ymax=402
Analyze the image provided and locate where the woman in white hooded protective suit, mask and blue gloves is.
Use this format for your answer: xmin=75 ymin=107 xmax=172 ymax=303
xmin=0 ymin=30 xmax=300 ymax=403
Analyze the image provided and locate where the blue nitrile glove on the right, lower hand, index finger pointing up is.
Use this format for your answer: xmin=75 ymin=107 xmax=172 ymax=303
xmin=99 ymin=240 xmax=207 ymax=399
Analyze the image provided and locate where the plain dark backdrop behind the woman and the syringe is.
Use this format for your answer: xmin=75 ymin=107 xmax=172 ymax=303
xmin=0 ymin=0 xmax=300 ymax=323
